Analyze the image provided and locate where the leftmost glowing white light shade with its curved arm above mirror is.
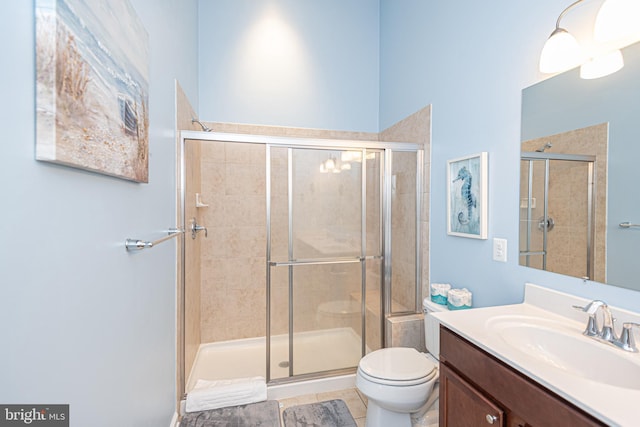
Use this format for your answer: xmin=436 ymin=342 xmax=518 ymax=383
xmin=540 ymin=0 xmax=585 ymax=74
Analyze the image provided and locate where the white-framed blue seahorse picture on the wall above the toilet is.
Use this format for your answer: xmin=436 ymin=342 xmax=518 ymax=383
xmin=447 ymin=152 xmax=488 ymax=239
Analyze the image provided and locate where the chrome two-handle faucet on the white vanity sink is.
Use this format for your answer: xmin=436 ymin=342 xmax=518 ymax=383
xmin=573 ymin=300 xmax=640 ymax=353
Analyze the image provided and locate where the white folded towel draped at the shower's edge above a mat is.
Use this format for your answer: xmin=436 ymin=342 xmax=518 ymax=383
xmin=186 ymin=377 xmax=267 ymax=412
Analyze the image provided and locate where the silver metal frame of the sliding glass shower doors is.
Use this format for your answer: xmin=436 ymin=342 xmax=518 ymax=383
xmin=177 ymin=131 xmax=424 ymax=397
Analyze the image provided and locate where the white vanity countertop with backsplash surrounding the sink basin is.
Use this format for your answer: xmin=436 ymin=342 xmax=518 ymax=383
xmin=432 ymin=284 xmax=640 ymax=427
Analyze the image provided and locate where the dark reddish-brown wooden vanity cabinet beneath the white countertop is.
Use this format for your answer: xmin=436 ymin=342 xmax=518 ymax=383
xmin=440 ymin=326 xmax=606 ymax=427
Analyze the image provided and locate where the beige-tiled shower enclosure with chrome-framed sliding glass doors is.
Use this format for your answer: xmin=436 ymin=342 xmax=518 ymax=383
xmin=180 ymin=132 xmax=423 ymax=398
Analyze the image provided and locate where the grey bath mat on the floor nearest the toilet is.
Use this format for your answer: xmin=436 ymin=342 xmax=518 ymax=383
xmin=282 ymin=399 xmax=356 ymax=427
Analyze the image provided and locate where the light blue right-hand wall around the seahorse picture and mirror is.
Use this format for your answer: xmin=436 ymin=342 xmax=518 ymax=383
xmin=380 ymin=0 xmax=640 ymax=310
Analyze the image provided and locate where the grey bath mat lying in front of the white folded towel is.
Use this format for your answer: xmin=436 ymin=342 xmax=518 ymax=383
xmin=180 ymin=400 xmax=280 ymax=427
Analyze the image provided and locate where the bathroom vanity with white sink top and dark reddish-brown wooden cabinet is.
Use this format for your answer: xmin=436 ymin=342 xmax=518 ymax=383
xmin=434 ymin=284 xmax=640 ymax=427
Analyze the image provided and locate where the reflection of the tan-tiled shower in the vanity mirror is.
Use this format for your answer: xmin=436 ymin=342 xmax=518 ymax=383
xmin=520 ymin=123 xmax=610 ymax=282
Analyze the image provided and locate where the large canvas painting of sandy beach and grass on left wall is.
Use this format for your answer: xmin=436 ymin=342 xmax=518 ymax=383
xmin=35 ymin=0 xmax=149 ymax=182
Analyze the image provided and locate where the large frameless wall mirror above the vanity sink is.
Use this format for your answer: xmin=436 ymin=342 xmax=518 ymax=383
xmin=519 ymin=43 xmax=640 ymax=290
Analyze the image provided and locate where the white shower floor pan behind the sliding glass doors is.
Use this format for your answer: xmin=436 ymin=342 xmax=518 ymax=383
xmin=186 ymin=328 xmax=361 ymax=392
